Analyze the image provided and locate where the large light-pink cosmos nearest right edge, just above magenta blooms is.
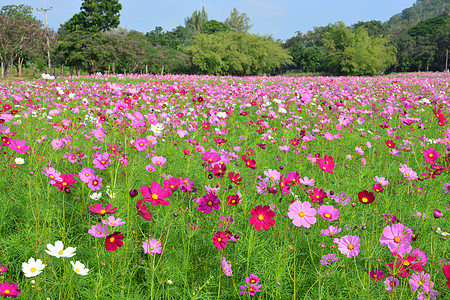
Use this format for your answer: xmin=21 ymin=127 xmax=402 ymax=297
xmin=380 ymin=223 xmax=412 ymax=255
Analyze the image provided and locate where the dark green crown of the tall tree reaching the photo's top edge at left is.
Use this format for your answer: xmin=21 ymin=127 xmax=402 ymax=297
xmin=64 ymin=0 xmax=122 ymax=33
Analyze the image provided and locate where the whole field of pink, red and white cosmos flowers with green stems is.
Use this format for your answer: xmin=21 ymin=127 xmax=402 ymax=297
xmin=0 ymin=73 xmax=450 ymax=299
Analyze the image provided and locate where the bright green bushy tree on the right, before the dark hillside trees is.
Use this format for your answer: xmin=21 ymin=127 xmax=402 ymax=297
xmin=323 ymin=22 xmax=395 ymax=75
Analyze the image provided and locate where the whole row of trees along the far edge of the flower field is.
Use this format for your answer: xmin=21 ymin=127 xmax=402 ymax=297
xmin=0 ymin=0 xmax=450 ymax=78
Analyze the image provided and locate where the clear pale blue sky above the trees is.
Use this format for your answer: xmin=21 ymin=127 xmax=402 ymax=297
xmin=0 ymin=0 xmax=415 ymax=40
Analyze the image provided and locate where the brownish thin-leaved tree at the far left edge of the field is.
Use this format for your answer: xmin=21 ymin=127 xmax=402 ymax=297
xmin=0 ymin=16 xmax=44 ymax=78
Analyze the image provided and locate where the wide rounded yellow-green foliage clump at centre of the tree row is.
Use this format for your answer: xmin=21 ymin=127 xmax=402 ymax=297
xmin=186 ymin=32 xmax=291 ymax=76
